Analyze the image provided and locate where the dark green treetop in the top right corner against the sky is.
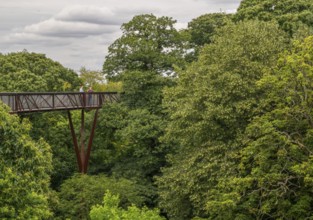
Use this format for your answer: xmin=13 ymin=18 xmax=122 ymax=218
xmin=235 ymin=0 xmax=313 ymax=36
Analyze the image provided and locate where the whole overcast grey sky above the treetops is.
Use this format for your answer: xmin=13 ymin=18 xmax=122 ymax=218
xmin=0 ymin=0 xmax=240 ymax=71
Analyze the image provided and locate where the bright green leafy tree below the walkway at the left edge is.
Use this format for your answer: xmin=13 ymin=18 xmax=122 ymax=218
xmin=0 ymin=103 xmax=52 ymax=219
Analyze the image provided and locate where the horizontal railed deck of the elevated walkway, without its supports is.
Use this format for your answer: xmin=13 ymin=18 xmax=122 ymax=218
xmin=0 ymin=92 xmax=119 ymax=113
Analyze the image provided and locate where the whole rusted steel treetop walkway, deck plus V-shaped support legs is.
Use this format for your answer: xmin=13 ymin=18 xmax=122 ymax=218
xmin=0 ymin=92 xmax=119 ymax=173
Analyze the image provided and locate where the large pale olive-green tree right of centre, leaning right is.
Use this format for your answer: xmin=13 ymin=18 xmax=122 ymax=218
xmin=158 ymin=19 xmax=285 ymax=219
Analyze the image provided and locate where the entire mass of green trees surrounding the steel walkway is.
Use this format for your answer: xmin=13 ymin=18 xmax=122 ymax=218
xmin=0 ymin=0 xmax=313 ymax=220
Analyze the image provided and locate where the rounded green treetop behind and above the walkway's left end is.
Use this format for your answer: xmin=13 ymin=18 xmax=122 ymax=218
xmin=0 ymin=51 xmax=80 ymax=92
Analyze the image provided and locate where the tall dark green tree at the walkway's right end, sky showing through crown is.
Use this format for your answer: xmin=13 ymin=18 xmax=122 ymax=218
xmin=95 ymin=14 xmax=185 ymax=208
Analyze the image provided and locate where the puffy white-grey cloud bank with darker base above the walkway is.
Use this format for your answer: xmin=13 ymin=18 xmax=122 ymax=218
xmin=15 ymin=5 xmax=121 ymax=38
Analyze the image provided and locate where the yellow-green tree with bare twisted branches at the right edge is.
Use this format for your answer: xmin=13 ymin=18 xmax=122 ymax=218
xmin=217 ymin=37 xmax=313 ymax=219
